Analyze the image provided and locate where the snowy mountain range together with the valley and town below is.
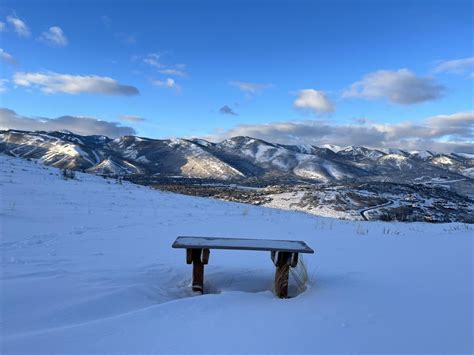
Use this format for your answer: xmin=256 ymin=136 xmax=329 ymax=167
xmin=0 ymin=130 xmax=474 ymax=223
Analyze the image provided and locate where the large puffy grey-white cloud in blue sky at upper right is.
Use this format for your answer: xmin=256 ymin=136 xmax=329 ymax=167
xmin=342 ymin=69 xmax=445 ymax=105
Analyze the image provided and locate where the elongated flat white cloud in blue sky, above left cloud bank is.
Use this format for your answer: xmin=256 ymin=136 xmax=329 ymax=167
xmin=13 ymin=72 xmax=139 ymax=96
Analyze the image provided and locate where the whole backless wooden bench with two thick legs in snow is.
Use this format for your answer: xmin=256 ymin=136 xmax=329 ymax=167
xmin=172 ymin=236 xmax=314 ymax=298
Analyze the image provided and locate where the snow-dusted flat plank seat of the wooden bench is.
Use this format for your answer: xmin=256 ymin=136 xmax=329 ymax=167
xmin=172 ymin=236 xmax=314 ymax=254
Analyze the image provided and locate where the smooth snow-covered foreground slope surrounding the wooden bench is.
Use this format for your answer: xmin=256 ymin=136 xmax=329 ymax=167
xmin=0 ymin=156 xmax=474 ymax=354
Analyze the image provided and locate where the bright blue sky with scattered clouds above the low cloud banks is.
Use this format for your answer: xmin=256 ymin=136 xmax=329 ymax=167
xmin=0 ymin=0 xmax=474 ymax=150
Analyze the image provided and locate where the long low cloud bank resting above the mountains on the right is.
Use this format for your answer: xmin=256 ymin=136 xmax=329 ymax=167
xmin=206 ymin=112 xmax=474 ymax=153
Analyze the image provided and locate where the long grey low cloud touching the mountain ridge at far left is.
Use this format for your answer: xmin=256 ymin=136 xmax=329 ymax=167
xmin=0 ymin=108 xmax=136 ymax=138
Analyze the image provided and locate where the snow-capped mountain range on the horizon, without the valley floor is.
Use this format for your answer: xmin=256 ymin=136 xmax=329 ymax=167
xmin=0 ymin=130 xmax=474 ymax=183
